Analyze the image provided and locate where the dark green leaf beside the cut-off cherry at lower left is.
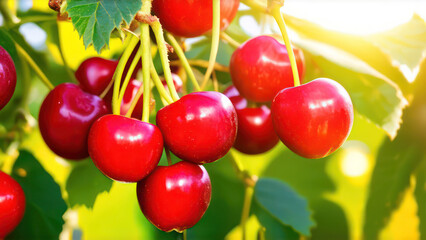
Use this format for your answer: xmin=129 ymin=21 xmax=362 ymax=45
xmin=7 ymin=151 xmax=67 ymax=240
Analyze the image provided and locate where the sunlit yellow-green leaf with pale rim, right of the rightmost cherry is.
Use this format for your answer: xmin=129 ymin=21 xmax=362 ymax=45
xmin=295 ymin=39 xmax=407 ymax=138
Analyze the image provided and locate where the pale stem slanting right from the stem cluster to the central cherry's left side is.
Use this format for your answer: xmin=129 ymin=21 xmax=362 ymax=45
xmin=151 ymin=21 xmax=179 ymax=101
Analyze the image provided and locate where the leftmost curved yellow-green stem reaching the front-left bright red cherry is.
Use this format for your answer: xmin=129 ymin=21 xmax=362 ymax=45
xmin=112 ymin=34 xmax=139 ymax=115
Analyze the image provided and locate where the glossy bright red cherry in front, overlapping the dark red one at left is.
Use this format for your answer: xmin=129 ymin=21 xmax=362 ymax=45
xmin=88 ymin=115 xmax=163 ymax=182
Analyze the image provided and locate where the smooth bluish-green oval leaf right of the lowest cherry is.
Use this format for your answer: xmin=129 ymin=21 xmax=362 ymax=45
xmin=254 ymin=178 xmax=314 ymax=236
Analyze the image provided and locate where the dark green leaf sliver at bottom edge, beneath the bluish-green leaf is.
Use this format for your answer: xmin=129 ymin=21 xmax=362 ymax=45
xmin=253 ymin=202 xmax=300 ymax=240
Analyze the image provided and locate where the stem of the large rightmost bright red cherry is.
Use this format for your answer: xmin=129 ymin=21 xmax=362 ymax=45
xmin=271 ymin=4 xmax=300 ymax=87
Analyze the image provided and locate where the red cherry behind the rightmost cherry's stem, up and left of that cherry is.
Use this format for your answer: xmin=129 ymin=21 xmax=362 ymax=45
xmin=229 ymin=36 xmax=304 ymax=102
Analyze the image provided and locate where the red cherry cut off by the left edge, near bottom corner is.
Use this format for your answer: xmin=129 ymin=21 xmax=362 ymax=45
xmin=0 ymin=171 xmax=25 ymax=239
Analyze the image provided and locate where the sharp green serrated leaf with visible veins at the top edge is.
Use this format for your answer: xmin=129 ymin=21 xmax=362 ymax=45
xmin=66 ymin=0 xmax=142 ymax=52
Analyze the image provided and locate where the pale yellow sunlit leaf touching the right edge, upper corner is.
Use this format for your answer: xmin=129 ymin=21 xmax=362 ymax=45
xmin=370 ymin=14 xmax=426 ymax=69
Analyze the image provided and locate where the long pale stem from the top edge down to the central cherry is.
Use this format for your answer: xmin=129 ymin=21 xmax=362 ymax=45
xmin=201 ymin=0 xmax=220 ymax=89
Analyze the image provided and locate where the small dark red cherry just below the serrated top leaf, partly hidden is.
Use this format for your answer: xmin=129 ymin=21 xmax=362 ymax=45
xmin=75 ymin=57 xmax=118 ymax=95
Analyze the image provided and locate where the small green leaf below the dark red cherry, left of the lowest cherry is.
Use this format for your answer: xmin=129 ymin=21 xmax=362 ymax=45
xmin=66 ymin=159 xmax=112 ymax=208
